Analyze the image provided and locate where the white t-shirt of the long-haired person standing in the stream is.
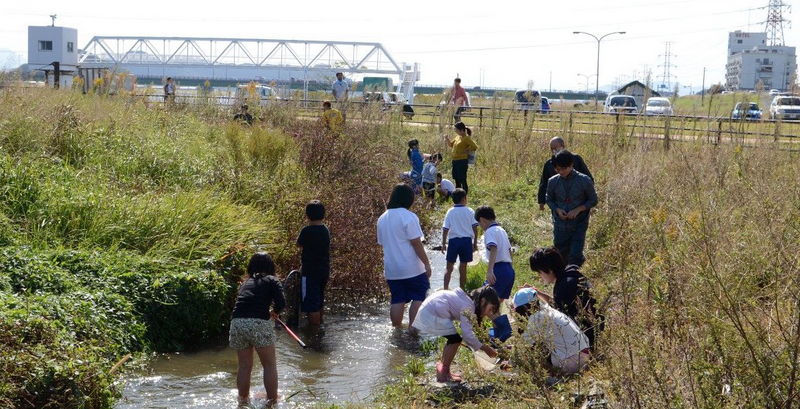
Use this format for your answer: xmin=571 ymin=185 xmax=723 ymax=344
xmin=378 ymin=207 xmax=425 ymax=280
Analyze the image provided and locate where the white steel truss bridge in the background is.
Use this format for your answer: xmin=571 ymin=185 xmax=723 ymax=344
xmin=78 ymin=36 xmax=419 ymax=99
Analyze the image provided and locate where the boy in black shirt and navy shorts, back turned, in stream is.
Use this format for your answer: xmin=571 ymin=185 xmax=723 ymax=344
xmin=297 ymin=200 xmax=331 ymax=325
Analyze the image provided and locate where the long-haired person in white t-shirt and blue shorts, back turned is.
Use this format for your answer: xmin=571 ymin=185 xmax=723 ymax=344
xmin=378 ymin=183 xmax=431 ymax=328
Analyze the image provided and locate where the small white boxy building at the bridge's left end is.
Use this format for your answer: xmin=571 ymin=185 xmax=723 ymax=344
xmin=28 ymin=26 xmax=78 ymax=88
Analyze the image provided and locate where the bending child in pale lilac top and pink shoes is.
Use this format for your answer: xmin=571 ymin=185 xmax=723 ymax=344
xmin=413 ymin=286 xmax=500 ymax=382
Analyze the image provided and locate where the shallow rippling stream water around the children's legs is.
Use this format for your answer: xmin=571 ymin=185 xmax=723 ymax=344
xmin=116 ymin=244 xmax=468 ymax=409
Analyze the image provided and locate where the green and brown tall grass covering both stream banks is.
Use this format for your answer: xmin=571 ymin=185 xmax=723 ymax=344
xmin=0 ymin=83 xmax=800 ymax=408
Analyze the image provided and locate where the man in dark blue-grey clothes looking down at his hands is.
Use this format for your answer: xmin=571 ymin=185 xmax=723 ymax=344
xmin=545 ymin=151 xmax=597 ymax=266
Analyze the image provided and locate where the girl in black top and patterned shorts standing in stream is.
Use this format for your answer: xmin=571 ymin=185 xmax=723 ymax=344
xmin=228 ymin=252 xmax=286 ymax=405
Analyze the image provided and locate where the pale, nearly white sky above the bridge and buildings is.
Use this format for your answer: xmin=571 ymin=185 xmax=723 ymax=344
xmin=0 ymin=0 xmax=800 ymax=93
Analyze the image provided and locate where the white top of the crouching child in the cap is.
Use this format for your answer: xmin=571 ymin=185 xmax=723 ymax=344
xmin=523 ymin=301 xmax=589 ymax=366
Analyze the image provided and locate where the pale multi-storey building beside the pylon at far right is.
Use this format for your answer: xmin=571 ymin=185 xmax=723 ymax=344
xmin=725 ymin=31 xmax=797 ymax=91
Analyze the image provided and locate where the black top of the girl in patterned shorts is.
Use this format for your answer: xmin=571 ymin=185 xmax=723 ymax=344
xmin=231 ymin=276 xmax=286 ymax=320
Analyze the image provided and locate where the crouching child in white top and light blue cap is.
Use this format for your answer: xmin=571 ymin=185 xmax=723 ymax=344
xmin=513 ymin=288 xmax=591 ymax=375
